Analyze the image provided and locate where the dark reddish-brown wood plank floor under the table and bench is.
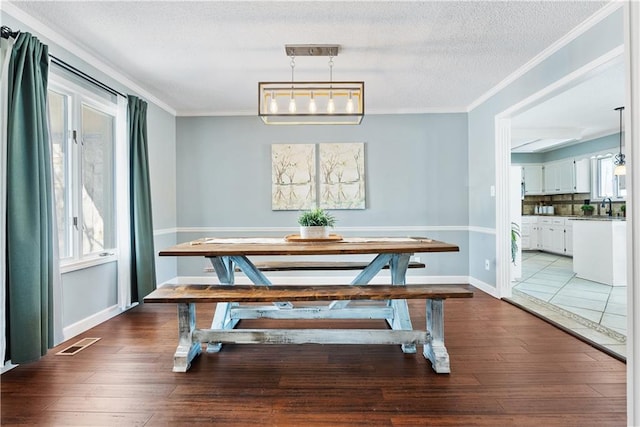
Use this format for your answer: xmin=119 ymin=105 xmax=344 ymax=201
xmin=0 ymin=290 xmax=626 ymax=427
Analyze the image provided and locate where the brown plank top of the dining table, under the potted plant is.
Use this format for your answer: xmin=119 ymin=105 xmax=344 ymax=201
xmin=159 ymin=237 xmax=460 ymax=257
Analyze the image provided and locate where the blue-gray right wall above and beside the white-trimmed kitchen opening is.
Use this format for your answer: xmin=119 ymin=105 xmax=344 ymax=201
xmin=469 ymin=9 xmax=624 ymax=286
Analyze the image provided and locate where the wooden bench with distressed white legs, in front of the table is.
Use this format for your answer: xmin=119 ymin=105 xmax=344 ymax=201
xmin=144 ymin=285 xmax=473 ymax=373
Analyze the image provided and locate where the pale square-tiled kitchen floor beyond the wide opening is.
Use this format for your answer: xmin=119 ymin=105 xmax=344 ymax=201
xmin=511 ymin=251 xmax=627 ymax=357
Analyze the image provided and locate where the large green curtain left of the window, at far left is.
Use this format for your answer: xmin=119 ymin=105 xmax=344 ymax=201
xmin=6 ymin=33 xmax=55 ymax=363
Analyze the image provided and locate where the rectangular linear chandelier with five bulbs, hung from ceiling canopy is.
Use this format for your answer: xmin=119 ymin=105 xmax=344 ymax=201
xmin=258 ymin=45 xmax=364 ymax=125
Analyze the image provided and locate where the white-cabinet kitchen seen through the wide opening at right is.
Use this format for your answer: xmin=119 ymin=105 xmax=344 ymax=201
xmin=511 ymin=59 xmax=626 ymax=358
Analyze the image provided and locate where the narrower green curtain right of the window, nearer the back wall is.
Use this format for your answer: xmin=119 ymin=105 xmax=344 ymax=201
xmin=128 ymin=95 xmax=156 ymax=303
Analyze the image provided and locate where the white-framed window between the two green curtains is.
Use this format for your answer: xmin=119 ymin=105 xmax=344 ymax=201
xmin=48 ymin=75 xmax=117 ymax=265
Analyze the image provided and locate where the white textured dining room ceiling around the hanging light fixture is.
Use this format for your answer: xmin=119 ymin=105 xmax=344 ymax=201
xmin=9 ymin=1 xmax=606 ymax=115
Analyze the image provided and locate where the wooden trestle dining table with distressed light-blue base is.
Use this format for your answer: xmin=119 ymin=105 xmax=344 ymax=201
xmin=159 ymin=237 xmax=459 ymax=362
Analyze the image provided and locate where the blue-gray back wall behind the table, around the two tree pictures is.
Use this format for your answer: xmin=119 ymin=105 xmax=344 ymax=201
xmin=176 ymin=114 xmax=468 ymax=275
